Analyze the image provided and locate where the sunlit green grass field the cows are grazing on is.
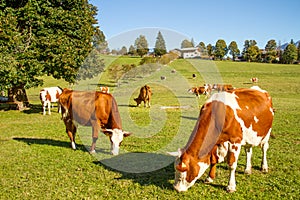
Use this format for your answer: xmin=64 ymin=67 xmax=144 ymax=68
xmin=0 ymin=56 xmax=300 ymax=200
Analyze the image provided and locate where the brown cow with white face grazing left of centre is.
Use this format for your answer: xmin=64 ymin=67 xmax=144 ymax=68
xmin=59 ymin=89 xmax=130 ymax=155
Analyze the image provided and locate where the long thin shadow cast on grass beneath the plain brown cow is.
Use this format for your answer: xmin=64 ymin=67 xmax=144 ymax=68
xmin=13 ymin=137 xmax=88 ymax=152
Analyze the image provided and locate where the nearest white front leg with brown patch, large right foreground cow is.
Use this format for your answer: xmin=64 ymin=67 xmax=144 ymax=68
xmin=227 ymin=144 xmax=241 ymax=192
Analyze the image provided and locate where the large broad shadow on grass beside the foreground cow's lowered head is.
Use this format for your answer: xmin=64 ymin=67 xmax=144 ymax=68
xmin=94 ymin=153 xmax=175 ymax=190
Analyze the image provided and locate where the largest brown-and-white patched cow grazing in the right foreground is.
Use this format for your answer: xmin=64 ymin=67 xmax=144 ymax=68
xmin=174 ymin=87 xmax=274 ymax=192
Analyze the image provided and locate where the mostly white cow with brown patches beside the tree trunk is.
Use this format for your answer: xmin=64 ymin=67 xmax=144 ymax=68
xmin=40 ymin=87 xmax=62 ymax=115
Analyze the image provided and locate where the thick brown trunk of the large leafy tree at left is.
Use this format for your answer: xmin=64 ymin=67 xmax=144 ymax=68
xmin=8 ymin=85 xmax=29 ymax=110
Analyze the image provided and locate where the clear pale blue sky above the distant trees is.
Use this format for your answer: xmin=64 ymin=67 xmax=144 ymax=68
xmin=89 ymin=0 xmax=300 ymax=50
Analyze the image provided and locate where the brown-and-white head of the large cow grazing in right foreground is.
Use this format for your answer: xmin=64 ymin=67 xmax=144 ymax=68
xmin=173 ymin=150 xmax=209 ymax=192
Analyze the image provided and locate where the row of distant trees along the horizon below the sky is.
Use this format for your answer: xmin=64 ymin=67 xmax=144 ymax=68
xmin=111 ymin=31 xmax=300 ymax=64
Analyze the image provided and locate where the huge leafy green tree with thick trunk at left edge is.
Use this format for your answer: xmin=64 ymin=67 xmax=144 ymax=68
xmin=0 ymin=0 xmax=103 ymax=107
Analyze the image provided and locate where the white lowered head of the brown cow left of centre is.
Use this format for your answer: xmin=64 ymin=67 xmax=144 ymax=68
xmin=102 ymin=128 xmax=131 ymax=155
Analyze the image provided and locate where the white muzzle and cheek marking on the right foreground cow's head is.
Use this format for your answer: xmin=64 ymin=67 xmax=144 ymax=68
xmin=174 ymin=162 xmax=209 ymax=192
